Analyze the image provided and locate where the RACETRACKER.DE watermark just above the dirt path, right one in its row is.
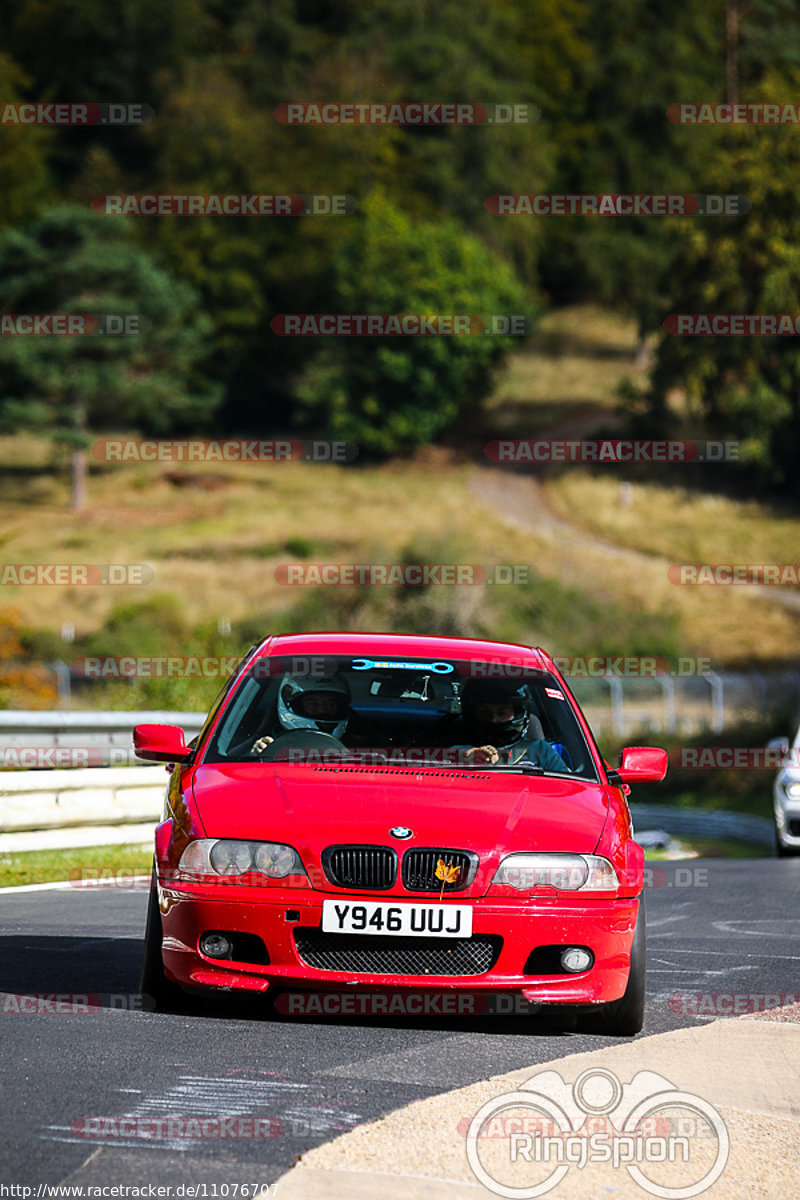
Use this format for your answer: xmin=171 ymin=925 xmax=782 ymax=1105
xmin=483 ymin=438 xmax=739 ymax=463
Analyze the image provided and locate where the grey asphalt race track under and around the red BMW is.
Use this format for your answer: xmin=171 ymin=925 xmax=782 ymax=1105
xmin=0 ymin=859 xmax=800 ymax=1196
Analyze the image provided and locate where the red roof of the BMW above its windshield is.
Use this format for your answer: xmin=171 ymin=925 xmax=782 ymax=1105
xmin=254 ymin=632 xmax=555 ymax=671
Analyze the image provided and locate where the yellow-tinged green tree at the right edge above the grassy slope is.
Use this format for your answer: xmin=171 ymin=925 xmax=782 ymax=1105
xmin=650 ymin=73 xmax=800 ymax=497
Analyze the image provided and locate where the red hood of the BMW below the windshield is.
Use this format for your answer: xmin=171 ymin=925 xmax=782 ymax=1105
xmin=193 ymin=763 xmax=608 ymax=888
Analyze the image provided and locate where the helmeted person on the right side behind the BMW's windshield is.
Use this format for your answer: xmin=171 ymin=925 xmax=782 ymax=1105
xmin=462 ymin=679 xmax=569 ymax=773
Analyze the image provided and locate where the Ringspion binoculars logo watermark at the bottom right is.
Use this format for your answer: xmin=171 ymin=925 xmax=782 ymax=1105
xmin=459 ymin=1067 xmax=730 ymax=1200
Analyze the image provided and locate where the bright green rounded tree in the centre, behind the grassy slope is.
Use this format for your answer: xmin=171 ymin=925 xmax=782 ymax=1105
xmin=297 ymin=194 xmax=527 ymax=455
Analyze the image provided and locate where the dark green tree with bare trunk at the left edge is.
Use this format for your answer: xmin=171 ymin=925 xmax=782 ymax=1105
xmin=0 ymin=206 xmax=219 ymax=508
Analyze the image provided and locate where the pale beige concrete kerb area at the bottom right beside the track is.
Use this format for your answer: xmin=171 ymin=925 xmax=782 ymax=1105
xmin=273 ymin=1007 xmax=800 ymax=1200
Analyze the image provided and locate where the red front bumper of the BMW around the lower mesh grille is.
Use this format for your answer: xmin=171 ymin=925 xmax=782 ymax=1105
xmin=158 ymin=882 xmax=639 ymax=1004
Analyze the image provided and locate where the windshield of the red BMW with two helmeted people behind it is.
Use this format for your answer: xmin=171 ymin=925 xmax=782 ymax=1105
xmin=204 ymin=655 xmax=597 ymax=780
